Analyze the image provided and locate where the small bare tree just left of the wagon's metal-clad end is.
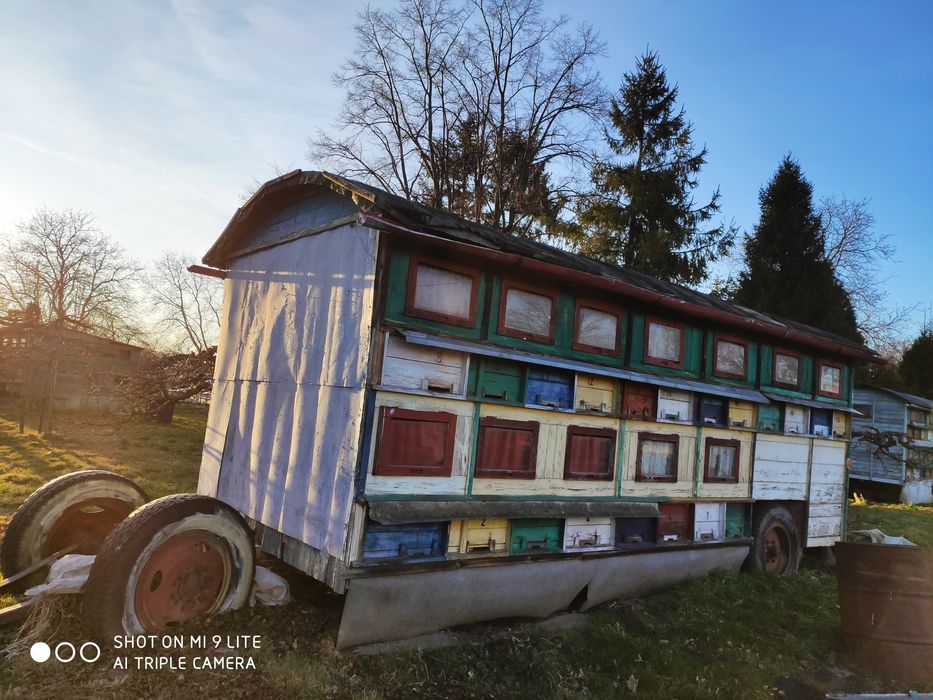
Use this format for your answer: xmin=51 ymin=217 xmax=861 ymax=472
xmin=144 ymin=252 xmax=223 ymax=353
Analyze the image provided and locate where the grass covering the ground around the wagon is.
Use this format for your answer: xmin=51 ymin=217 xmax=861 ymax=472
xmin=0 ymin=407 xmax=933 ymax=700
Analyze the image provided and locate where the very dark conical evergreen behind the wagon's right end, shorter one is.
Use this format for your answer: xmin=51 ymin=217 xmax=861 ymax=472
xmin=734 ymin=156 xmax=861 ymax=340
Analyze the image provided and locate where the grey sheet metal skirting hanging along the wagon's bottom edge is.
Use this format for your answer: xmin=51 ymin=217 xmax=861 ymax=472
xmin=337 ymin=540 xmax=749 ymax=649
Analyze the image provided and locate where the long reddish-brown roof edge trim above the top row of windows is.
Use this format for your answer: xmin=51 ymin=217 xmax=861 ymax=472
xmin=360 ymin=213 xmax=885 ymax=364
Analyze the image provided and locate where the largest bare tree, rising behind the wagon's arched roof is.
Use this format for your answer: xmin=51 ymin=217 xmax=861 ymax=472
xmin=309 ymin=0 xmax=606 ymax=234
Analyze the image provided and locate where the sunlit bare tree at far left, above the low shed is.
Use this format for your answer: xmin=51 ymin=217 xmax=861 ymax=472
xmin=0 ymin=208 xmax=140 ymax=340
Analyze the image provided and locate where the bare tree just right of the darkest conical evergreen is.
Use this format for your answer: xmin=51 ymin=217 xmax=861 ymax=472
xmin=817 ymin=195 xmax=916 ymax=352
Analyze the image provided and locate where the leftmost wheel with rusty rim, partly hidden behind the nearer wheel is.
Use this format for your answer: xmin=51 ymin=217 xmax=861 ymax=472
xmin=0 ymin=469 xmax=149 ymax=590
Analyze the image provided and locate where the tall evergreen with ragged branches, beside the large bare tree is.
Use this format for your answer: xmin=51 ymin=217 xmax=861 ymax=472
xmin=569 ymin=52 xmax=735 ymax=284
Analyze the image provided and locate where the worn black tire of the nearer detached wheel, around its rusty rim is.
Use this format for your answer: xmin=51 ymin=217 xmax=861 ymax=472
xmin=84 ymin=494 xmax=255 ymax=641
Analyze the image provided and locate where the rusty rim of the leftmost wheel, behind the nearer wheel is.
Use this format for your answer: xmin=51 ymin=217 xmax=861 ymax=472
xmin=42 ymin=498 xmax=136 ymax=557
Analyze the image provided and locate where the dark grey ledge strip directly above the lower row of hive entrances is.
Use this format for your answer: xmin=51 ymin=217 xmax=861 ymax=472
xmin=369 ymin=499 xmax=661 ymax=525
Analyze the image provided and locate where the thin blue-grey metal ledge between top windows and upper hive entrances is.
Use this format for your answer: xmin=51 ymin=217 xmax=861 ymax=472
xmin=399 ymin=330 xmax=768 ymax=407
